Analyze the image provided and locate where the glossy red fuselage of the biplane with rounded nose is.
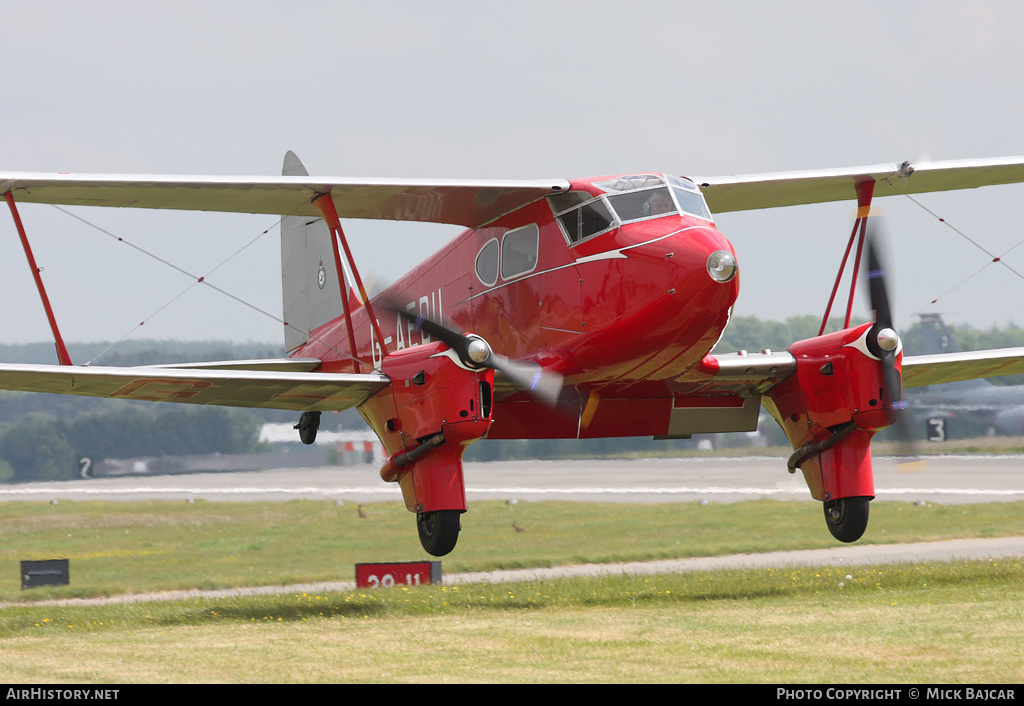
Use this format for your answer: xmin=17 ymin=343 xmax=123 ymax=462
xmin=295 ymin=176 xmax=738 ymax=438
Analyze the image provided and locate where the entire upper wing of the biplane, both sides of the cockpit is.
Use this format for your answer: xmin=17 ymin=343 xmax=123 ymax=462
xmin=8 ymin=157 xmax=1024 ymax=227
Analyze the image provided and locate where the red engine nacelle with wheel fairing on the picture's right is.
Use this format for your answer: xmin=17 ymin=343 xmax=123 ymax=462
xmin=763 ymin=324 xmax=902 ymax=501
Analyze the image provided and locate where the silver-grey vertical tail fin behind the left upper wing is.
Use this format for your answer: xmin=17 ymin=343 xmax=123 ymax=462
xmin=281 ymin=152 xmax=343 ymax=351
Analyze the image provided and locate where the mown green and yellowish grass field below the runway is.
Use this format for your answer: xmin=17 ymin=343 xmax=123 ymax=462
xmin=0 ymin=500 xmax=1024 ymax=683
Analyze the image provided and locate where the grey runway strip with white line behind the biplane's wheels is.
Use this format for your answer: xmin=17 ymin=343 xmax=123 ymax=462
xmin=0 ymin=455 xmax=1024 ymax=504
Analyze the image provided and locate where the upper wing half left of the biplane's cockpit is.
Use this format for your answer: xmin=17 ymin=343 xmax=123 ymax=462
xmin=0 ymin=173 xmax=569 ymax=227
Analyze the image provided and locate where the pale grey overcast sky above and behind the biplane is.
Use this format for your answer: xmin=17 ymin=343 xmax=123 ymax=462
xmin=0 ymin=0 xmax=1024 ymax=352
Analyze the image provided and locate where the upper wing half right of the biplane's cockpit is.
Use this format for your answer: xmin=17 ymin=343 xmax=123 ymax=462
xmin=693 ymin=157 xmax=1024 ymax=213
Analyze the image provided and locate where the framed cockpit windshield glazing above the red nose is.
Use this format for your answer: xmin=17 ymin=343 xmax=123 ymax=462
xmin=548 ymin=174 xmax=712 ymax=243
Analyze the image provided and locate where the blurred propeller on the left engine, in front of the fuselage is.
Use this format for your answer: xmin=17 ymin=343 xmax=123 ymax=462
xmin=395 ymin=308 xmax=562 ymax=405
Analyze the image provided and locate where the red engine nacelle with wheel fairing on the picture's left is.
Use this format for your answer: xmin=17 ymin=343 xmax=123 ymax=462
xmin=359 ymin=341 xmax=495 ymax=513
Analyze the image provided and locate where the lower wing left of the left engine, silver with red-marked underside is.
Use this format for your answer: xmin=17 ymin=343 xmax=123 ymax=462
xmin=0 ymin=359 xmax=390 ymax=411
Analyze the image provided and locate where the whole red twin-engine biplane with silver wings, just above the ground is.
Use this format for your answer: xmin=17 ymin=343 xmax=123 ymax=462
xmin=0 ymin=153 xmax=1024 ymax=556
